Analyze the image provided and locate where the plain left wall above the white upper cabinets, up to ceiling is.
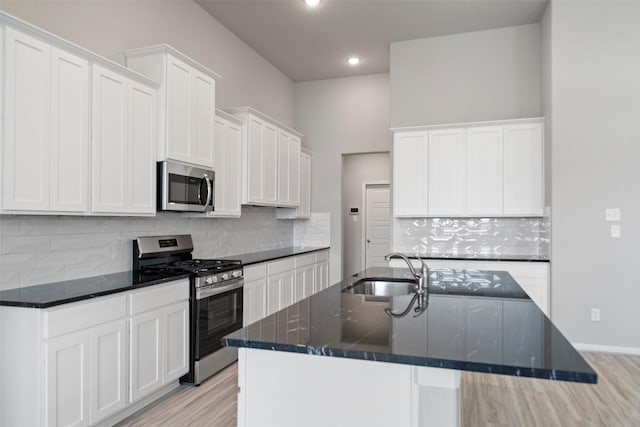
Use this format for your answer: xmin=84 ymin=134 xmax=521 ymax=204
xmin=0 ymin=0 xmax=293 ymax=126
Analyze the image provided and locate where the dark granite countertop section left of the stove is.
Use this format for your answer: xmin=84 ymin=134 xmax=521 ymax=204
xmin=0 ymin=271 xmax=189 ymax=308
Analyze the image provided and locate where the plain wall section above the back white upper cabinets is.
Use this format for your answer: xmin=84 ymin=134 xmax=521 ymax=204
xmin=390 ymin=24 xmax=541 ymax=127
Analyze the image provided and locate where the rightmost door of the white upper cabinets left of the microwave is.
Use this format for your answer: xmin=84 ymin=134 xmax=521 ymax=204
xmin=127 ymin=82 xmax=156 ymax=214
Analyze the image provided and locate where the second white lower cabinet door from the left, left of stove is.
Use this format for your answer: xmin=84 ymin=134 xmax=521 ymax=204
xmin=90 ymin=319 xmax=128 ymax=424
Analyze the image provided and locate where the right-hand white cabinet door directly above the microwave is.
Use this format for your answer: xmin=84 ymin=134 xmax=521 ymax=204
xmin=191 ymin=70 xmax=216 ymax=167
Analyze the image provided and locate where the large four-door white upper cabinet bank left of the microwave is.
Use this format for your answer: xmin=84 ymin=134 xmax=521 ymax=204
xmin=0 ymin=13 xmax=157 ymax=215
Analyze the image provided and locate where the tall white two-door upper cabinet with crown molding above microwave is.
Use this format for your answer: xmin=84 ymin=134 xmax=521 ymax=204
xmin=125 ymin=45 xmax=220 ymax=168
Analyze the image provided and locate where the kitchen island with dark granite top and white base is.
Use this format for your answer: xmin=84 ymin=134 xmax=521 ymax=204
xmin=225 ymin=268 xmax=597 ymax=426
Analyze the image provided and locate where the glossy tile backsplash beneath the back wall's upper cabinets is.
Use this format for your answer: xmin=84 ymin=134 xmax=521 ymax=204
xmin=393 ymin=217 xmax=550 ymax=257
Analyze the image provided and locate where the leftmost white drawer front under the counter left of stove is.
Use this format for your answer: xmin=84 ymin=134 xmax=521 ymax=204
xmin=42 ymin=294 xmax=127 ymax=339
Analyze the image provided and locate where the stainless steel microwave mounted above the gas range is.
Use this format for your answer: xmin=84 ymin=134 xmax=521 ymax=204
xmin=157 ymin=161 xmax=215 ymax=212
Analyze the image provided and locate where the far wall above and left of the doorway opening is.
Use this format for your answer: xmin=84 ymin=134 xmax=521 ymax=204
xmin=294 ymin=74 xmax=391 ymax=283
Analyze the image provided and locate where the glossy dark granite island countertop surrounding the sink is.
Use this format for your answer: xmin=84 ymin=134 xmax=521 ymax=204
xmin=224 ymin=268 xmax=597 ymax=383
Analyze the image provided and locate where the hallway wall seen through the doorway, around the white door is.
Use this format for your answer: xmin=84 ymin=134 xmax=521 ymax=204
xmin=340 ymin=153 xmax=391 ymax=276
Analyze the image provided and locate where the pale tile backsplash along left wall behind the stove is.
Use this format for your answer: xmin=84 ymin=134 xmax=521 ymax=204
xmin=0 ymin=206 xmax=302 ymax=289
